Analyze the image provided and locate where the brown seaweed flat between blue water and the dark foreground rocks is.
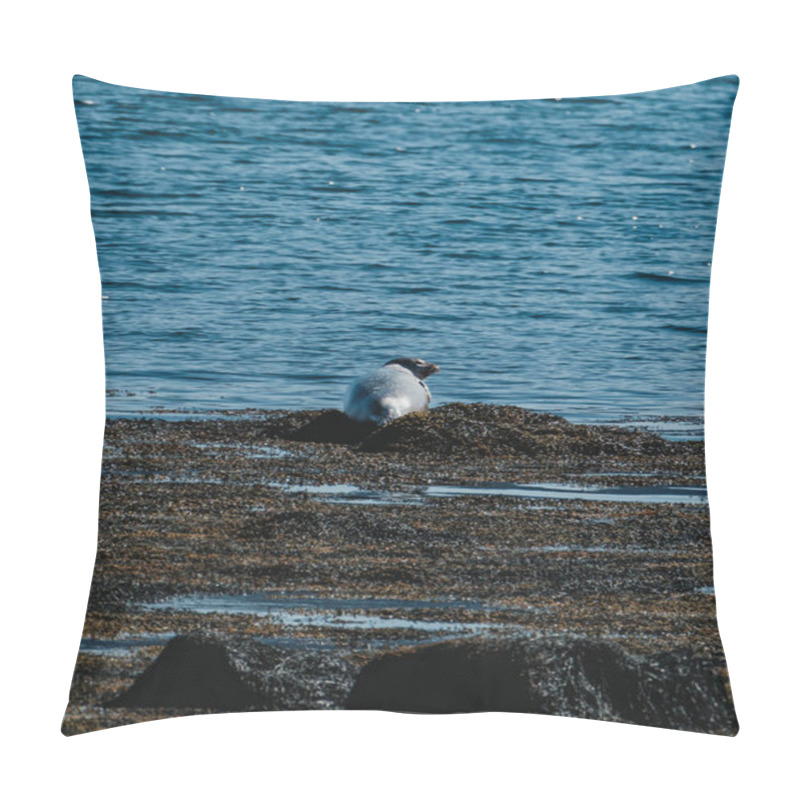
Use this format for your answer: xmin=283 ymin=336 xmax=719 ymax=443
xmin=64 ymin=404 xmax=726 ymax=734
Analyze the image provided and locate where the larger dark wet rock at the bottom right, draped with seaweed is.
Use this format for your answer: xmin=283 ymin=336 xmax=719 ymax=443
xmin=346 ymin=638 xmax=738 ymax=735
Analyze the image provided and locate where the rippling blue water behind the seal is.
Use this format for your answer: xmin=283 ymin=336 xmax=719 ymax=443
xmin=75 ymin=77 xmax=737 ymax=421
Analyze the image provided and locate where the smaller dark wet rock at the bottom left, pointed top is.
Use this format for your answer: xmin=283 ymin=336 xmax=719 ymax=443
xmin=109 ymin=632 xmax=355 ymax=711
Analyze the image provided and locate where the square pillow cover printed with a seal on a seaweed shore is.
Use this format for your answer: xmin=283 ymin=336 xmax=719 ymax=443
xmin=63 ymin=76 xmax=738 ymax=735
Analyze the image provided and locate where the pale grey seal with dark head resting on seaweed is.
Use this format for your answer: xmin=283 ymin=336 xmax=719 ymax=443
xmin=344 ymin=358 xmax=439 ymax=425
